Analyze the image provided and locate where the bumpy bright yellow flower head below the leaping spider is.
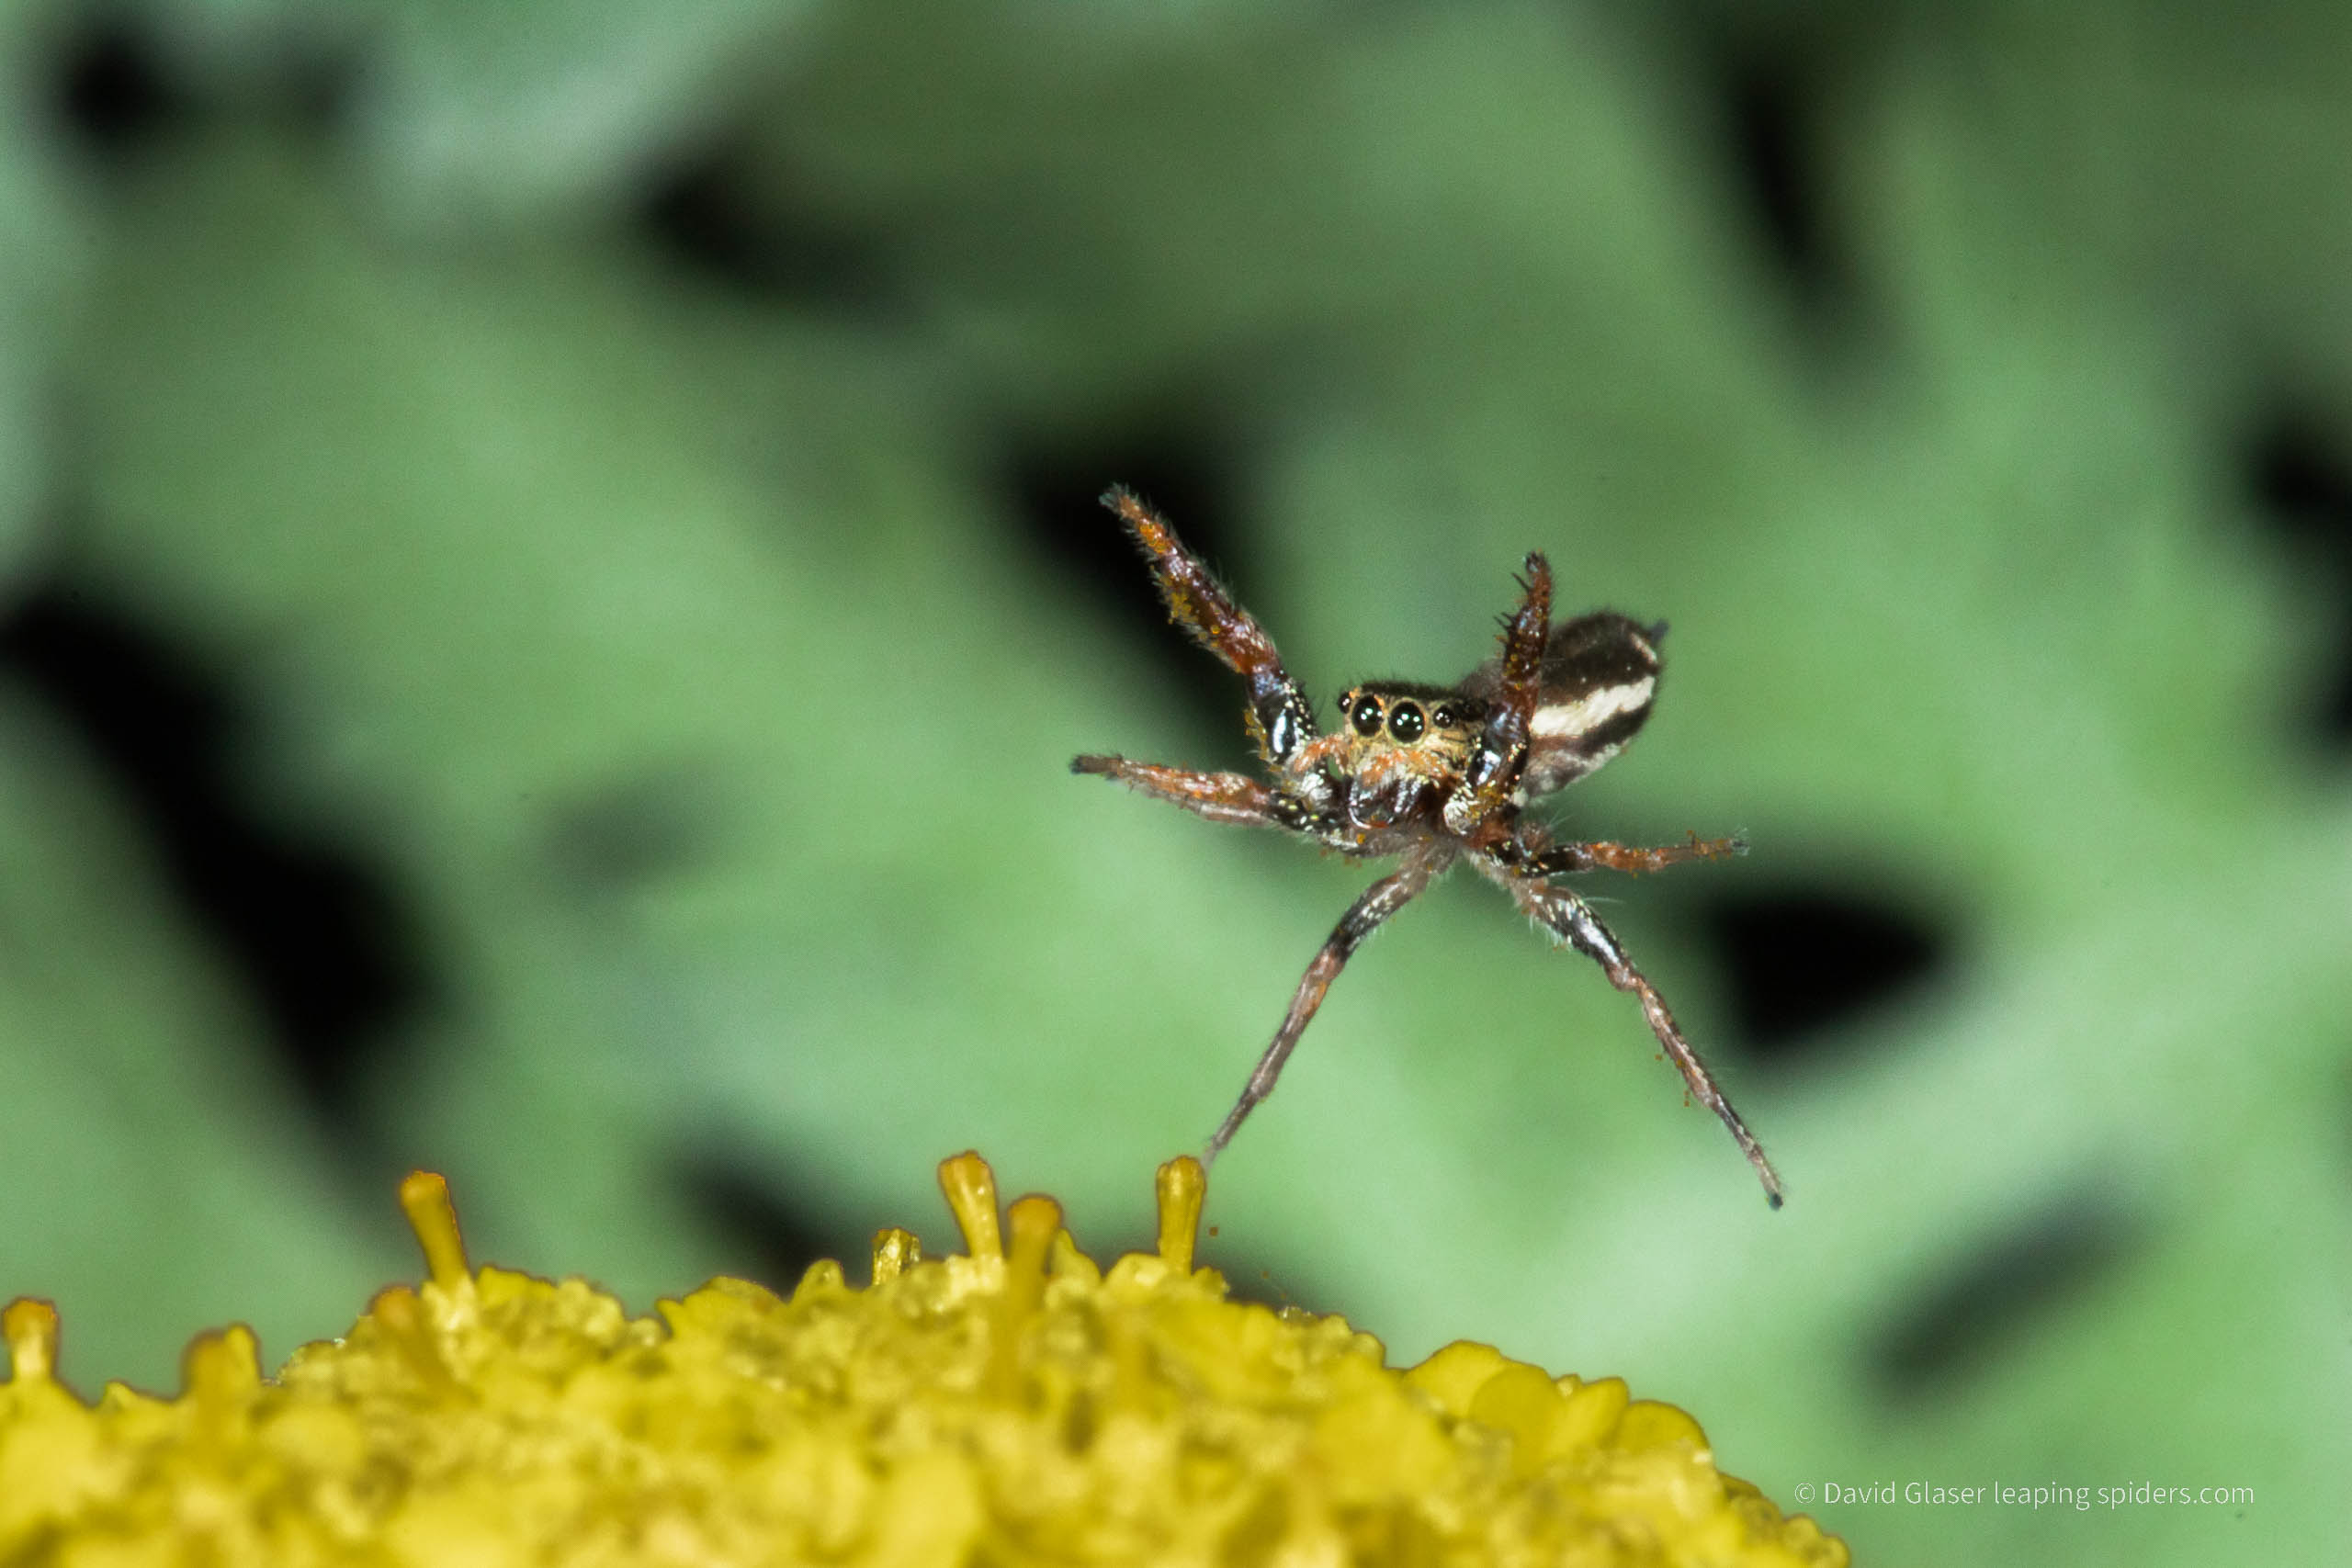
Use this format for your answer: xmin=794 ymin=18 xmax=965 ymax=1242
xmin=0 ymin=1155 xmax=1847 ymax=1568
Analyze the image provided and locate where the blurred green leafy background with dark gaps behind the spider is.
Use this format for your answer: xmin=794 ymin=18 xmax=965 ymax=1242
xmin=0 ymin=0 xmax=2352 ymax=1565
